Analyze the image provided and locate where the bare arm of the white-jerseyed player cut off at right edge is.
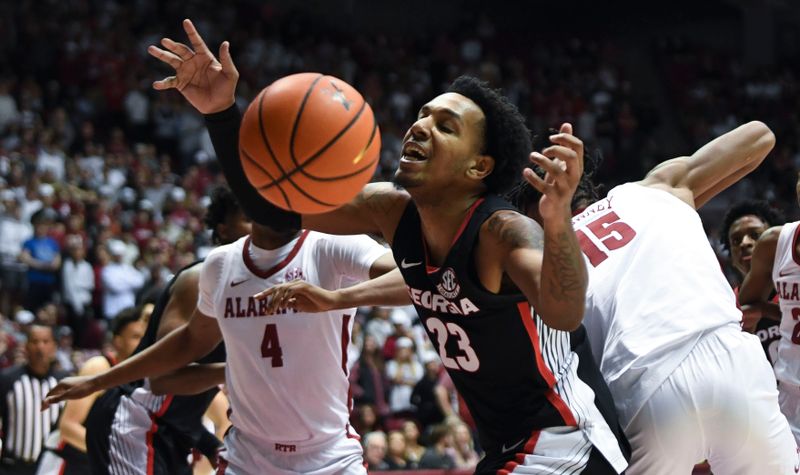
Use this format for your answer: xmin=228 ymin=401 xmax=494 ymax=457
xmin=739 ymin=226 xmax=782 ymax=331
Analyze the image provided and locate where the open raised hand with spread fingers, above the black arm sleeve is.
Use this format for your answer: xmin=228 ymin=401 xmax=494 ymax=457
xmin=147 ymin=20 xmax=239 ymax=114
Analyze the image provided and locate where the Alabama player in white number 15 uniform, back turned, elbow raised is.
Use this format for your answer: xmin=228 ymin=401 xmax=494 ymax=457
xmin=515 ymin=122 xmax=800 ymax=475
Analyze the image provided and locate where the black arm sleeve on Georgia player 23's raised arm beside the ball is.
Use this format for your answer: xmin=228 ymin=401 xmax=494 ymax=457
xmin=205 ymin=104 xmax=301 ymax=231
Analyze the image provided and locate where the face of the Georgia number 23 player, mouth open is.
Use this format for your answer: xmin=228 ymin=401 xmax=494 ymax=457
xmin=394 ymin=93 xmax=485 ymax=195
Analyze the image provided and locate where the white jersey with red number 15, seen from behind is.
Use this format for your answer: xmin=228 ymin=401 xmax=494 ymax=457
xmin=572 ymin=183 xmax=742 ymax=427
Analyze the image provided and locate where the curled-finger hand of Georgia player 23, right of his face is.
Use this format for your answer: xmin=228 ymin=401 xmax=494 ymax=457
xmin=522 ymin=123 xmax=583 ymax=220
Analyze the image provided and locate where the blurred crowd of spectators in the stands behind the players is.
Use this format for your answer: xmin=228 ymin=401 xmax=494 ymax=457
xmin=0 ymin=0 xmax=800 ymax=469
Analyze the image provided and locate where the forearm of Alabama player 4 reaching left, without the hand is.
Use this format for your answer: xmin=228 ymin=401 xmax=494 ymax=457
xmin=95 ymin=325 xmax=213 ymax=390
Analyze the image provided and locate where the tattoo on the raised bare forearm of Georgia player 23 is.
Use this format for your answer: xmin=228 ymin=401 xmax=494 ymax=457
xmin=545 ymin=231 xmax=583 ymax=302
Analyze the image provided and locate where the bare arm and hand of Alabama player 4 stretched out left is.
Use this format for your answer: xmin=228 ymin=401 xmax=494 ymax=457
xmin=42 ymin=311 xmax=222 ymax=409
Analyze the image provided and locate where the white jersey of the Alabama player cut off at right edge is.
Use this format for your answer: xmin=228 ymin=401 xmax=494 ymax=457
xmin=772 ymin=221 xmax=800 ymax=386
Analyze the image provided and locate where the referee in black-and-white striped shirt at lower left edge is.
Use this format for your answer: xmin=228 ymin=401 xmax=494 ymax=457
xmin=0 ymin=323 xmax=67 ymax=475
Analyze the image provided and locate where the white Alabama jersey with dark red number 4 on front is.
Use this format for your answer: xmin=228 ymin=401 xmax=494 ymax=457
xmin=197 ymin=231 xmax=388 ymax=452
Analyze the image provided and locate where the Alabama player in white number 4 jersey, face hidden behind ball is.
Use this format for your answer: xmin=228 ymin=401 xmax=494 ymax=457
xmin=46 ymin=220 xmax=396 ymax=475
